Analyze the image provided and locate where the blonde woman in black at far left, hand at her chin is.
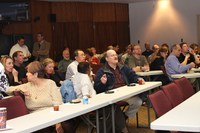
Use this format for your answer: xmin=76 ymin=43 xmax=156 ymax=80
xmin=1 ymin=56 xmax=20 ymax=86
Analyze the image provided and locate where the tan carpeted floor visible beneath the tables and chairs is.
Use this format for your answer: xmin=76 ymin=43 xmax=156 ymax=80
xmin=76 ymin=106 xmax=155 ymax=133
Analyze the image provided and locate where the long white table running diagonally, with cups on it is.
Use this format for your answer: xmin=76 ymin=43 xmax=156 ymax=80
xmin=4 ymin=82 xmax=161 ymax=133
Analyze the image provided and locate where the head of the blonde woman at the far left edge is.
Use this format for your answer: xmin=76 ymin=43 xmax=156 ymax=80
xmin=1 ymin=56 xmax=13 ymax=73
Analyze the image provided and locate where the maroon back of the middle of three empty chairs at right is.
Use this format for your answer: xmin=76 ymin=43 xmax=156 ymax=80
xmin=162 ymin=83 xmax=183 ymax=107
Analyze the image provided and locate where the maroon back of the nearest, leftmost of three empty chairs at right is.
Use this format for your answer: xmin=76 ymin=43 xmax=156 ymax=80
xmin=148 ymin=90 xmax=173 ymax=117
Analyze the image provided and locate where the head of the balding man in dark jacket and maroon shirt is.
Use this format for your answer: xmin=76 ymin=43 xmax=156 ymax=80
xmin=105 ymin=49 xmax=118 ymax=65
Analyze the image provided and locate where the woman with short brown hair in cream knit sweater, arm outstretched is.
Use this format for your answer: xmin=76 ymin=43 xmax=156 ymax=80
xmin=7 ymin=61 xmax=74 ymax=133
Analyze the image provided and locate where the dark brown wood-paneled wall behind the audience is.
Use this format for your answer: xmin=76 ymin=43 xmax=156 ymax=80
xmin=3 ymin=0 xmax=130 ymax=59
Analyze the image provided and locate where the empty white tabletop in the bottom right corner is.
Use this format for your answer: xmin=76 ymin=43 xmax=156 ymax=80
xmin=151 ymin=92 xmax=200 ymax=132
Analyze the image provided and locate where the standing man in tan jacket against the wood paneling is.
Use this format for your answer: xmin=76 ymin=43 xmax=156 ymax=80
xmin=33 ymin=33 xmax=50 ymax=61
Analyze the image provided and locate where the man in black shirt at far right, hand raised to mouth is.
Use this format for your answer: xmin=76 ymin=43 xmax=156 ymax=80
xmin=178 ymin=42 xmax=200 ymax=65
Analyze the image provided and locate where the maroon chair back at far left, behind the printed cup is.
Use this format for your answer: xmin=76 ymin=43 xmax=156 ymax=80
xmin=0 ymin=96 xmax=29 ymax=120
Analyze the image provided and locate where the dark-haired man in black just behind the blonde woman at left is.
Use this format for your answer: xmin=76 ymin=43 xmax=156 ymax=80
xmin=12 ymin=51 xmax=27 ymax=81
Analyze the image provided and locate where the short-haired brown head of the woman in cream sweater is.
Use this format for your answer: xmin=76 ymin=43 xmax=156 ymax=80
xmin=26 ymin=61 xmax=44 ymax=82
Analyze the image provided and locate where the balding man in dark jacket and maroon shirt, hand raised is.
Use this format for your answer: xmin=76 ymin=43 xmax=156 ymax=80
xmin=94 ymin=50 xmax=144 ymax=118
